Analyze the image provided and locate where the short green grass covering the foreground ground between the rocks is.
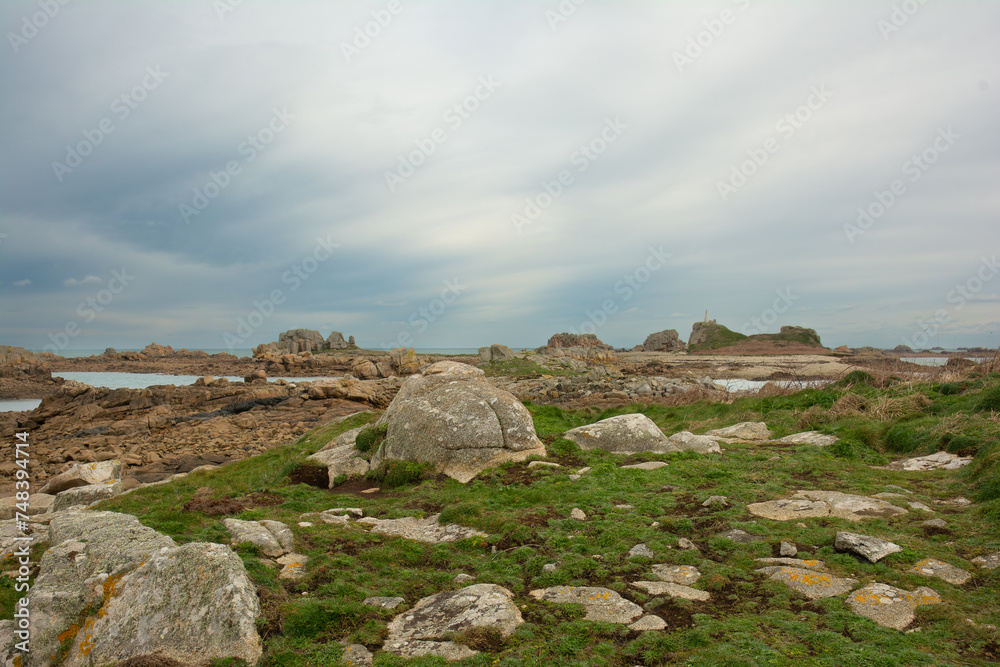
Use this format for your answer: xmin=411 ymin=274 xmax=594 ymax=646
xmin=9 ymin=374 xmax=1000 ymax=667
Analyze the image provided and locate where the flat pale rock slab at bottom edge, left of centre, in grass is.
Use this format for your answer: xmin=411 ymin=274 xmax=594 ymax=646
xmin=382 ymin=584 xmax=524 ymax=660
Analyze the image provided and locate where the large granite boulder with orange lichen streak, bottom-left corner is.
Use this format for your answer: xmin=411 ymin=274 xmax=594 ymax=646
xmin=0 ymin=511 xmax=262 ymax=667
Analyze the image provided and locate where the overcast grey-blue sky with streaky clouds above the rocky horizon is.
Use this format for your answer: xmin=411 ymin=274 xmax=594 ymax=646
xmin=0 ymin=0 xmax=1000 ymax=350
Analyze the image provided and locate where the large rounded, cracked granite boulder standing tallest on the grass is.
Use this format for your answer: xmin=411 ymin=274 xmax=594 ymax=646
xmin=371 ymin=361 xmax=545 ymax=483
